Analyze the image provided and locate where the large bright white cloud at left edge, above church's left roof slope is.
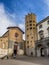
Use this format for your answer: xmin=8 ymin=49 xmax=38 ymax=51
xmin=0 ymin=4 xmax=15 ymax=36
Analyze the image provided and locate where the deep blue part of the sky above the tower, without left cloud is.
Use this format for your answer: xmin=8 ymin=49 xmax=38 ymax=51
xmin=0 ymin=0 xmax=49 ymax=23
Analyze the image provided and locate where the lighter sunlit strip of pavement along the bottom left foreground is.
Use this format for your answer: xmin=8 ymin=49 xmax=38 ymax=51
xmin=0 ymin=59 xmax=38 ymax=65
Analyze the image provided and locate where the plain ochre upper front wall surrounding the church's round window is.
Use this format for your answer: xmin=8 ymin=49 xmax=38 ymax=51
xmin=9 ymin=28 xmax=23 ymax=42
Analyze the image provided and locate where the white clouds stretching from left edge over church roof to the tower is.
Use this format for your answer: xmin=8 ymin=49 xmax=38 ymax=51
xmin=0 ymin=4 xmax=25 ymax=39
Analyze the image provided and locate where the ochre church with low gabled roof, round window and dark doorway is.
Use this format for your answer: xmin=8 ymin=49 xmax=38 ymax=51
xmin=0 ymin=27 xmax=24 ymax=55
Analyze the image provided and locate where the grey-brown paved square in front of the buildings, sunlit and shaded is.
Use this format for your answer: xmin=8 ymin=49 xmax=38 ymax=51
xmin=0 ymin=56 xmax=49 ymax=65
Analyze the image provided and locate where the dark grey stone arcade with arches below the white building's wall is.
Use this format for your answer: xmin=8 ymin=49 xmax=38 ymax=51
xmin=35 ymin=37 xmax=49 ymax=57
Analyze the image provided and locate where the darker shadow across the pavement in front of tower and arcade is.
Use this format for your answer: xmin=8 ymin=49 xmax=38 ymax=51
xmin=13 ymin=55 xmax=49 ymax=65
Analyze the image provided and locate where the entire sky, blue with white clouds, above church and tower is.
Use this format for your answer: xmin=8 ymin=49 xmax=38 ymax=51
xmin=0 ymin=0 xmax=49 ymax=38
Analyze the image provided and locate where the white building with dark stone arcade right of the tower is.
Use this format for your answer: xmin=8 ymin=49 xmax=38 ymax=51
xmin=35 ymin=16 xmax=49 ymax=56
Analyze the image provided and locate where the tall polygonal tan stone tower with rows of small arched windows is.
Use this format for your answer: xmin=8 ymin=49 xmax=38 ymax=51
xmin=25 ymin=13 xmax=37 ymax=55
